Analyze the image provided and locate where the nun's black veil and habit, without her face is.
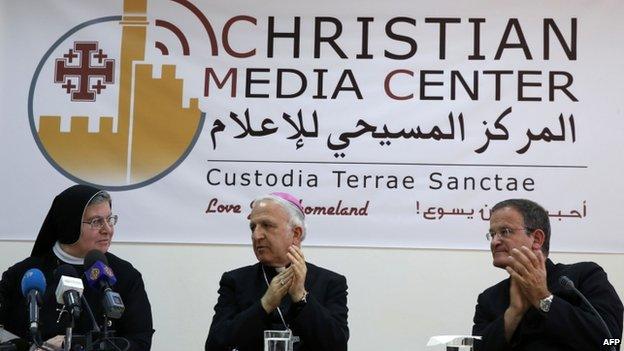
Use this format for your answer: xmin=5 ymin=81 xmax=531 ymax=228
xmin=0 ymin=185 xmax=154 ymax=351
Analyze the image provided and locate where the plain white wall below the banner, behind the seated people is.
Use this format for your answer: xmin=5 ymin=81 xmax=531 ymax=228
xmin=0 ymin=241 xmax=624 ymax=351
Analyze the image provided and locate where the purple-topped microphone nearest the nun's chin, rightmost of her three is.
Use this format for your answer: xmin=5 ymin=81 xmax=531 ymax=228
xmin=84 ymin=250 xmax=126 ymax=319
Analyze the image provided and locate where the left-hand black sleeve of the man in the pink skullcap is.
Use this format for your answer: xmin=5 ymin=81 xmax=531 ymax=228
xmin=205 ymin=273 xmax=269 ymax=351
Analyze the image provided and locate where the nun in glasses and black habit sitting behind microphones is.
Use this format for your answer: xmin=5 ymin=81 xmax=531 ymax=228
xmin=0 ymin=185 xmax=154 ymax=351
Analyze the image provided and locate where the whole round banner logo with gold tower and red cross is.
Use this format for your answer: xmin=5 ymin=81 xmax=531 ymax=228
xmin=28 ymin=0 xmax=205 ymax=190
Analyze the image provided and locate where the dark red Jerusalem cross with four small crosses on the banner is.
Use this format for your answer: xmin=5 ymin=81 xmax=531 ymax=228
xmin=54 ymin=41 xmax=115 ymax=101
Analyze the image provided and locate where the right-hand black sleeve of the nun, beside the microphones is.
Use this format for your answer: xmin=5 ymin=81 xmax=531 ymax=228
xmin=117 ymin=272 xmax=154 ymax=351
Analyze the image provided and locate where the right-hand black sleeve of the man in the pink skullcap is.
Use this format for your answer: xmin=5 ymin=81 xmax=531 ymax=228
xmin=291 ymin=275 xmax=349 ymax=351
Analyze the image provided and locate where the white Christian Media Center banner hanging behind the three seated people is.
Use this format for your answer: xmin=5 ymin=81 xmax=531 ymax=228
xmin=0 ymin=0 xmax=624 ymax=252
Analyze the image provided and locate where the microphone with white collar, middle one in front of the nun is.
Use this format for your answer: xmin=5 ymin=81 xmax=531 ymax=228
xmin=54 ymin=264 xmax=84 ymax=319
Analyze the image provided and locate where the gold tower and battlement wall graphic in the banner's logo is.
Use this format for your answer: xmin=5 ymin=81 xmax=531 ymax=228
xmin=38 ymin=0 xmax=202 ymax=186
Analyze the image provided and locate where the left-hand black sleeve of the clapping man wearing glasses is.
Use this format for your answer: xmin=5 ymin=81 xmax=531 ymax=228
xmin=472 ymin=294 xmax=510 ymax=351
